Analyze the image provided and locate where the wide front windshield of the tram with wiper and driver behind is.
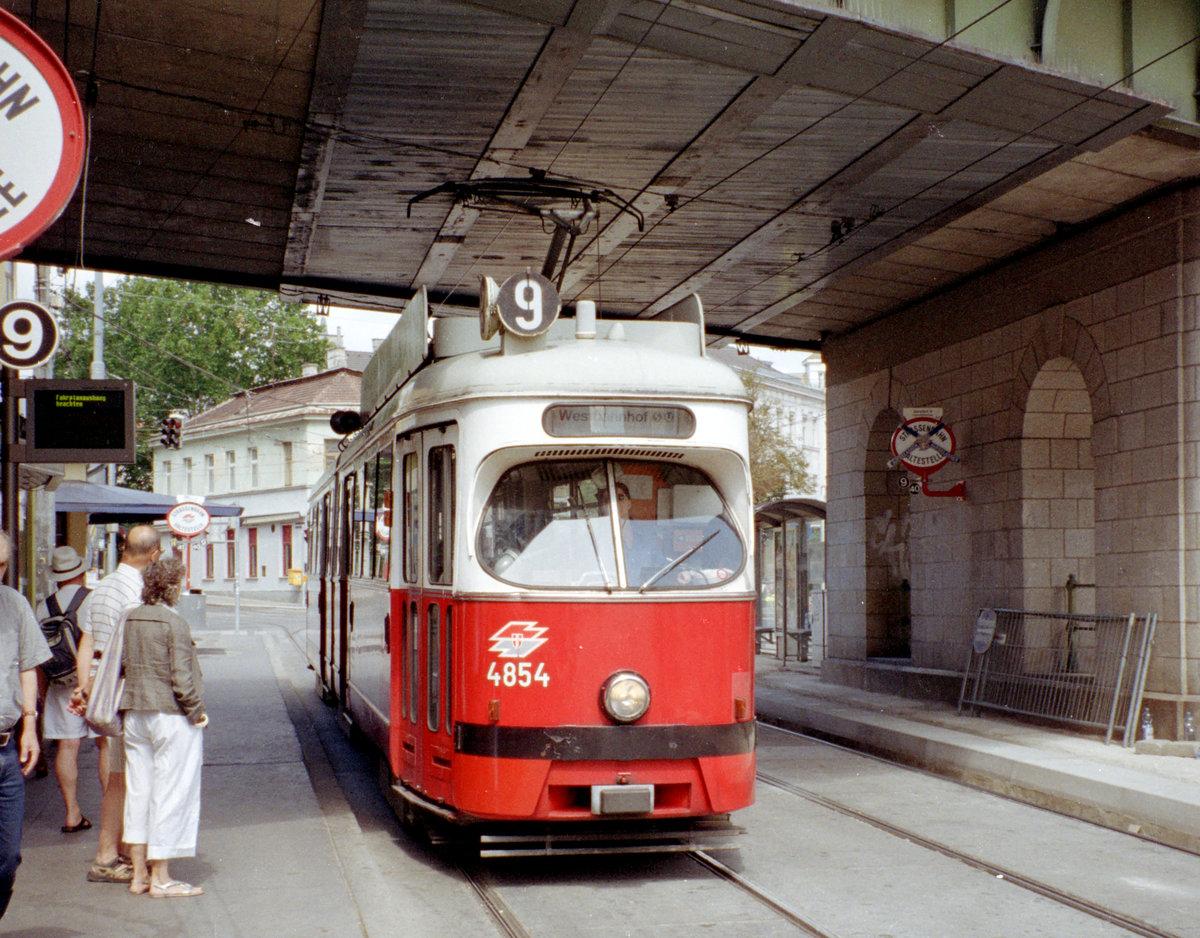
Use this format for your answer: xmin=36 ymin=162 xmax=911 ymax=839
xmin=479 ymin=459 xmax=745 ymax=593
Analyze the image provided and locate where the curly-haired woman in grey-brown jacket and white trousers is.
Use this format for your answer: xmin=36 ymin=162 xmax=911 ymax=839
xmin=121 ymin=557 xmax=209 ymax=898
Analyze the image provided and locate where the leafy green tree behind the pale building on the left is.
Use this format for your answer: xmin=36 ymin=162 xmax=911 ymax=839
xmin=54 ymin=277 xmax=329 ymax=489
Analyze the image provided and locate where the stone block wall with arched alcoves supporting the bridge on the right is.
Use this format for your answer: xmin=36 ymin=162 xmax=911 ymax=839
xmin=824 ymin=187 xmax=1200 ymax=734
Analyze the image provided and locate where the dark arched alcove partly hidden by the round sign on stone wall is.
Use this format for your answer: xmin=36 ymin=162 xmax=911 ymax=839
xmin=863 ymin=408 xmax=912 ymax=657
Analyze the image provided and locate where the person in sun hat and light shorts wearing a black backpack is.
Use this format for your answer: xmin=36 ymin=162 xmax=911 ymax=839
xmin=37 ymin=547 xmax=91 ymax=834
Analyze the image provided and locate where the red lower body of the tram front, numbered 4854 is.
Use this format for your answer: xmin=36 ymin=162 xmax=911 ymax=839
xmin=390 ymin=593 xmax=755 ymax=822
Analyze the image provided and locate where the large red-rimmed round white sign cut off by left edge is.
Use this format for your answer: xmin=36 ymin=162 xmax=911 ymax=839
xmin=0 ymin=10 xmax=84 ymax=260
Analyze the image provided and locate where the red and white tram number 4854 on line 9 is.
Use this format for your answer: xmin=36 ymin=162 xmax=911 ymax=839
xmin=308 ymin=275 xmax=755 ymax=853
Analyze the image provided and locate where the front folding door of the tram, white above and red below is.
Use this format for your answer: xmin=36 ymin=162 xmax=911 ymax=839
xmin=392 ymin=426 xmax=457 ymax=801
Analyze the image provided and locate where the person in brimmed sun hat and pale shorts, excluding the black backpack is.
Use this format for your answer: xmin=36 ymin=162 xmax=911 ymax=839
xmin=37 ymin=547 xmax=91 ymax=834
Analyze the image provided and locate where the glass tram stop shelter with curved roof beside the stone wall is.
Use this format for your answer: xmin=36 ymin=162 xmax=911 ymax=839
xmin=755 ymin=498 xmax=826 ymax=661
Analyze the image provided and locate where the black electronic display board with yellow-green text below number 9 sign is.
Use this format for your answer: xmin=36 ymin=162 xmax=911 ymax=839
xmin=24 ymin=378 xmax=136 ymax=463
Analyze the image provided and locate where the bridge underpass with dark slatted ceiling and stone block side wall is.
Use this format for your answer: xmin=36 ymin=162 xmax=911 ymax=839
xmin=2 ymin=0 xmax=1200 ymax=734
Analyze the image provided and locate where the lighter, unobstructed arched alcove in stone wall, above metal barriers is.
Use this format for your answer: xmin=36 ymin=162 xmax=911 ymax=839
xmin=1021 ymin=356 xmax=1096 ymax=612
